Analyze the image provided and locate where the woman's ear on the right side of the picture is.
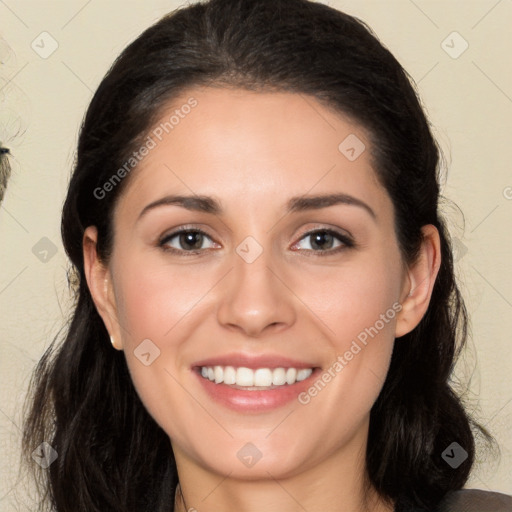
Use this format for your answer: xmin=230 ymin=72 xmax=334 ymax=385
xmin=395 ymin=224 xmax=441 ymax=338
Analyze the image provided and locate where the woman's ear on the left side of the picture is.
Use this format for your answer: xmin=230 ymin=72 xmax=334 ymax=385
xmin=82 ymin=226 xmax=122 ymax=350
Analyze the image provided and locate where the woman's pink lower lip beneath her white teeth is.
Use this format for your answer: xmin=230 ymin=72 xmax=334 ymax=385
xmin=194 ymin=368 xmax=321 ymax=412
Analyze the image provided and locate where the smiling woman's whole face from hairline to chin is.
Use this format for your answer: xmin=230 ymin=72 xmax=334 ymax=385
xmin=84 ymin=88 xmax=436 ymax=479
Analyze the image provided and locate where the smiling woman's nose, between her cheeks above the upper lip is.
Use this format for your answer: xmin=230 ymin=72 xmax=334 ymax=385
xmin=217 ymin=245 xmax=297 ymax=337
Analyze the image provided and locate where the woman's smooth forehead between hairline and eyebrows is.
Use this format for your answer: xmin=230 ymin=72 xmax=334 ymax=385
xmin=114 ymin=88 xmax=389 ymax=222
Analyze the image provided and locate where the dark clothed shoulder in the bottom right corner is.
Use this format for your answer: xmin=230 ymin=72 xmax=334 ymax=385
xmin=436 ymin=489 xmax=512 ymax=512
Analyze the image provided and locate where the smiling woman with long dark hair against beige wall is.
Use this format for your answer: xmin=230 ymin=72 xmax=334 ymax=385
xmin=24 ymin=0 xmax=510 ymax=512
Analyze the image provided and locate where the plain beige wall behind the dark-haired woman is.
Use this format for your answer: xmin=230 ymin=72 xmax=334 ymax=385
xmin=0 ymin=0 xmax=512 ymax=511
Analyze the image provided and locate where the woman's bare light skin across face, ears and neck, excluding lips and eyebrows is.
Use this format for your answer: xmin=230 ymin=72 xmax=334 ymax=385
xmin=83 ymin=88 xmax=440 ymax=512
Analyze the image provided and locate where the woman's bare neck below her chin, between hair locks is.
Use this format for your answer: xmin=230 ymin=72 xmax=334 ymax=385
xmin=174 ymin=428 xmax=394 ymax=512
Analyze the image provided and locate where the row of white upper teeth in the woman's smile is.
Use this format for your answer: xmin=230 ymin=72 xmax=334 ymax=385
xmin=201 ymin=366 xmax=313 ymax=388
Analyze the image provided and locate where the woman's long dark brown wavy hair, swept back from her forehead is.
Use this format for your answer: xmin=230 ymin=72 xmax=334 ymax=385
xmin=23 ymin=0 xmax=492 ymax=512
